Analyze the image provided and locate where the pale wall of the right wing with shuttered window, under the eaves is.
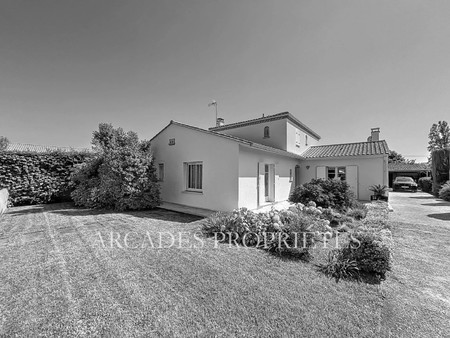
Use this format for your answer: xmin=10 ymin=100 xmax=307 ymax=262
xmin=300 ymin=155 xmax=388 ymax=201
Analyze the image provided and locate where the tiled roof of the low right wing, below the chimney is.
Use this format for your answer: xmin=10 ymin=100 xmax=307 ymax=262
xmin=302 ymin=140 xmax=389 ymax=158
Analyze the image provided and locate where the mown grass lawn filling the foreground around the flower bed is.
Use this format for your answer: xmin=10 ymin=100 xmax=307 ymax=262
xmin=0 ymin=204 xmax=450 ymax=337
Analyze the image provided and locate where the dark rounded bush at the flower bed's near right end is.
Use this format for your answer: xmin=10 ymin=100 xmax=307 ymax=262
xmin=342 ymin=230 xmax=392 ymax=280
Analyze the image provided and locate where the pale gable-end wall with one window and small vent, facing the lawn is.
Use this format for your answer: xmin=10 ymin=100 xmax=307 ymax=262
xmin=151 ymin=124 xmax=239 ymax=211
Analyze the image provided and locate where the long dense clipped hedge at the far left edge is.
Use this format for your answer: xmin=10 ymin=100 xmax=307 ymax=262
xmin=0 ymin=152 xmax=91 ymax=206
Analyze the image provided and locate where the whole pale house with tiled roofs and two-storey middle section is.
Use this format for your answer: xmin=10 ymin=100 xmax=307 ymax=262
xmin=151 ymin=112 xmax=389 ymax=211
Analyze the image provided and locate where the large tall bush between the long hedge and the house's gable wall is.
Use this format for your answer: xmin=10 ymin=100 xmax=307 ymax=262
xmin=71 ymin=124 xmax=160 ymax=210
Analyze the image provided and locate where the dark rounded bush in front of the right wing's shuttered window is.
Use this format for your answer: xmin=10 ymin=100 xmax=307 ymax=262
xmin=289 ymin=179 xmax=355 ymax=210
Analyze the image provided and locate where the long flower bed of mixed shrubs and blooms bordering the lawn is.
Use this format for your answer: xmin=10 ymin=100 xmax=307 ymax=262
xmin=203 ymin=202 xmax=392 ymax=280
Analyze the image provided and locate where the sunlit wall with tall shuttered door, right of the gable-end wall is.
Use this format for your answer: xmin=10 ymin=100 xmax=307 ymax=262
xmin=239 ymin=145 xmax=300 ymax=209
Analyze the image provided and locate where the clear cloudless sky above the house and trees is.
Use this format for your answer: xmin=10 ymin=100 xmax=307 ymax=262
xmin=0 ymin=0 xmax=450 ymax=160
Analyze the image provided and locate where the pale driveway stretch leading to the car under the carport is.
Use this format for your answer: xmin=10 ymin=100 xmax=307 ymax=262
xmin=389 ymin=192 xmax=450 ymax=229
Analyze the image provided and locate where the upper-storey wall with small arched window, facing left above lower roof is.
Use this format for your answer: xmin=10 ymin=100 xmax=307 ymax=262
xmin=218 ymin=119 xmax=286 ymax=150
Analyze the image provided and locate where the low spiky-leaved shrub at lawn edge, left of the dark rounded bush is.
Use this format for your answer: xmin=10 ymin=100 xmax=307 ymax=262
xmin=319 ymin=249 xmax=360 ymax=282
